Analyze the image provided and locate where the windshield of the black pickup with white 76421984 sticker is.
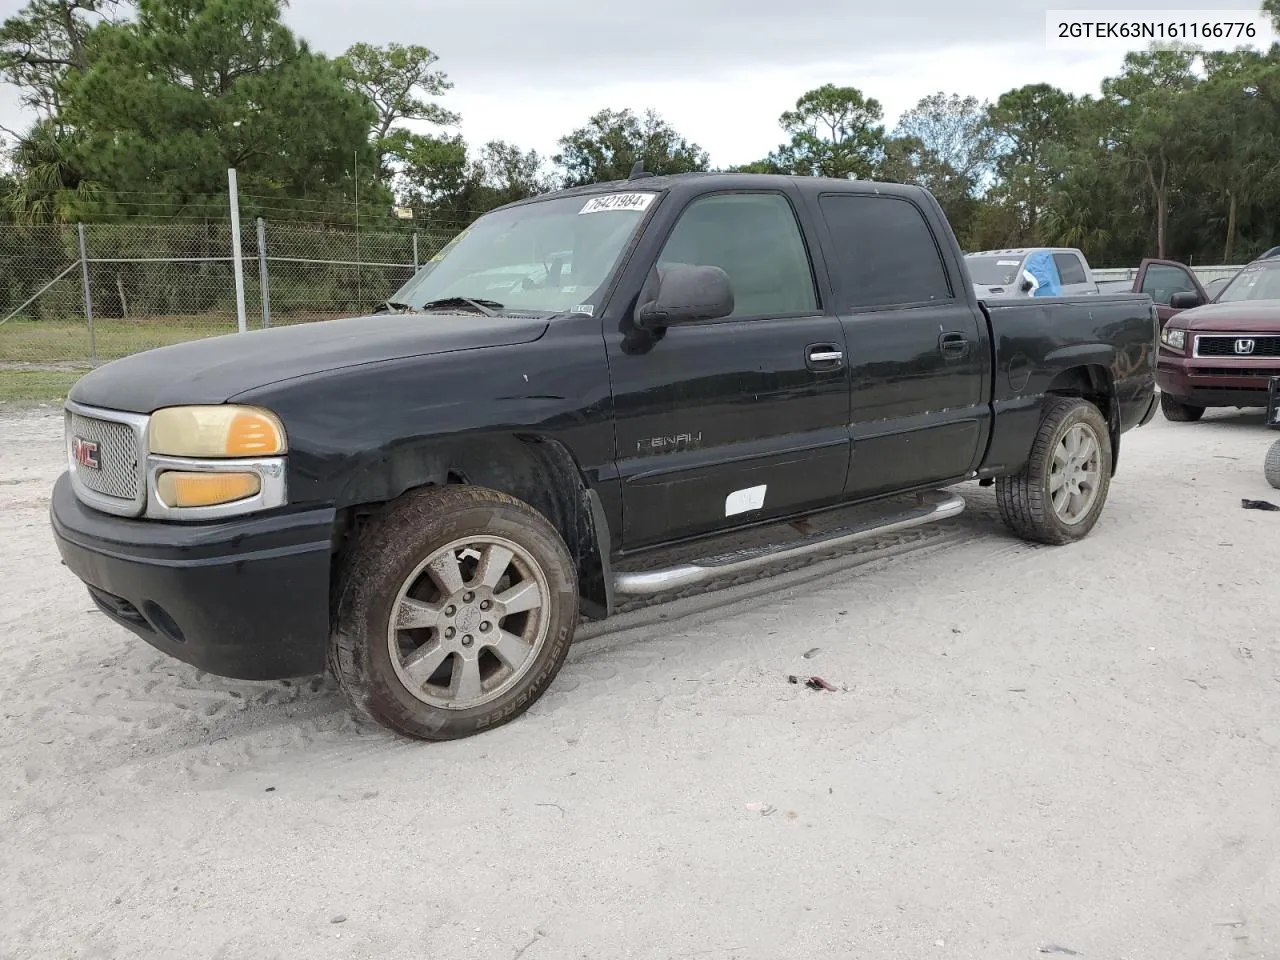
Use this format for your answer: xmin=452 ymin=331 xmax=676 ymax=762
xmin=390 ymin=193 xmax=658 ymax=314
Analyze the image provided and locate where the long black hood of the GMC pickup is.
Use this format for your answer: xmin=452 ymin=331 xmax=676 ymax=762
xmin=70 ymin=314 xmax=547 ymax=413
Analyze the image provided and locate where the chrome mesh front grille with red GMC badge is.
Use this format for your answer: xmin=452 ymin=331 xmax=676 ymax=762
xmin=65 ymin=403 xmax=147 ymax=516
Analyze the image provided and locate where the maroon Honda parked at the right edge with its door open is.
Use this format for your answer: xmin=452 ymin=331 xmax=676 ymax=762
xmin=1135 ymin=251 xmax=1280 ymax=422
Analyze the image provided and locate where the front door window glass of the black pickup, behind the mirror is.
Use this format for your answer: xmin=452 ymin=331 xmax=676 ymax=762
xmin=658 ymin=193 xmax=818 ymax=316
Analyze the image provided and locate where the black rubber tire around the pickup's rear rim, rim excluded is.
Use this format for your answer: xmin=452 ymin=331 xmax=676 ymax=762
xmin=996 ymin=397 xmax=1112 ymax=547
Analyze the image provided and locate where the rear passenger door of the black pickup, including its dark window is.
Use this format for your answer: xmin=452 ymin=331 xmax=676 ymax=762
xmin=817 ymin=192 xmax=991 ymax=498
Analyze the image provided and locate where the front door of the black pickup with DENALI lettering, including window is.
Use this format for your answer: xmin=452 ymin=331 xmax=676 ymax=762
xmin=605 ymin=191 xmax=849 ymax=549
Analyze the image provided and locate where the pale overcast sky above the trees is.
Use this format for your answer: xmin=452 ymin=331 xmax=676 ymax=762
xmin=0 ymin=0 xmax=1274 ymax=165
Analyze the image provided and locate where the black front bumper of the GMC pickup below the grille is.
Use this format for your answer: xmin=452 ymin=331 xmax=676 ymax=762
xmin=50 ymin=474 xmax=334 ymax=680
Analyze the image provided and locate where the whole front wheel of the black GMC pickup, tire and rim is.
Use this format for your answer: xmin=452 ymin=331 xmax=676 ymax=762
xmin=329 ymin=485 xmax=577 ymax=740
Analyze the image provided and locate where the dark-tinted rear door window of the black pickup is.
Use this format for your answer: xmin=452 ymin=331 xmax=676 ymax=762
xmin=818 ymin=193 xmax=952 ymax=310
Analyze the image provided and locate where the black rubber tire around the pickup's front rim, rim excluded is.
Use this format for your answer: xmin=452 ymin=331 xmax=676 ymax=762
xmin=329 ymin=485 xmax=579 ymax=740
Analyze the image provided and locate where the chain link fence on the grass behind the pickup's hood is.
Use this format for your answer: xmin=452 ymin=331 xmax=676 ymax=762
xmin=0 ymin=219 xmax=465 ymax=370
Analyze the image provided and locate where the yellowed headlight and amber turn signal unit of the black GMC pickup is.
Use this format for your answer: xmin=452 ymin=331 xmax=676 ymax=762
xmin=146 ymin=406 xmax=288 ymax=520
